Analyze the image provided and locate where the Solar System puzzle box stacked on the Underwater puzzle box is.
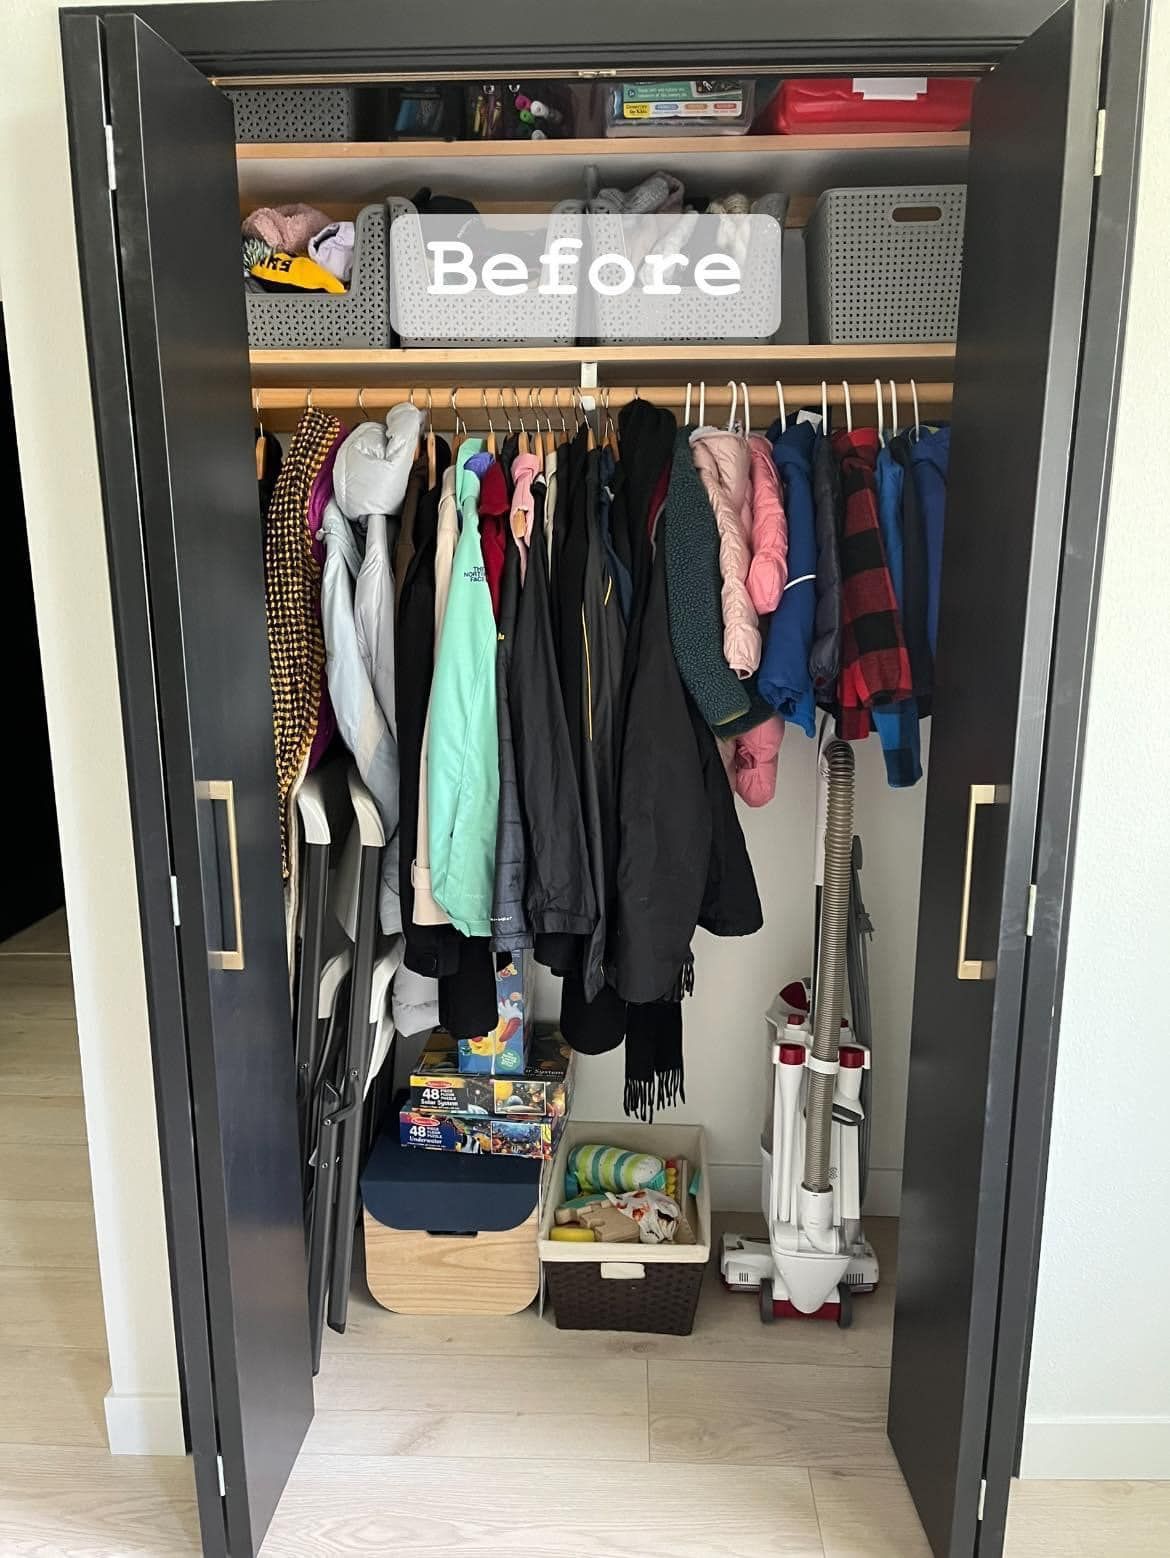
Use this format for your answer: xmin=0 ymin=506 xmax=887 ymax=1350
xmin=408 ymin=1027 xmax=573 ymax=1120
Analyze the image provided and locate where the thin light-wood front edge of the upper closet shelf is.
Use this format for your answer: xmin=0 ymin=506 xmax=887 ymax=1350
xmin=235 ymin=131 xmax=971 ymax=162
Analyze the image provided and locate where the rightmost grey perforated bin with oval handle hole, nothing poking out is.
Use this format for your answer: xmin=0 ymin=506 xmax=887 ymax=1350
xmin=805 ymin=184 xmax=967 ymax=344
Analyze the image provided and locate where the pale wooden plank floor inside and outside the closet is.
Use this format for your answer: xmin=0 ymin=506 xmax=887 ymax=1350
xmin=0 ymin=916 xmax=1170 ymax=1558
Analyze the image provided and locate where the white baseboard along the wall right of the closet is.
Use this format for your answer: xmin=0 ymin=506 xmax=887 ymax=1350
xmin=1020 ymin=1416 xmax=1170 ymax=1482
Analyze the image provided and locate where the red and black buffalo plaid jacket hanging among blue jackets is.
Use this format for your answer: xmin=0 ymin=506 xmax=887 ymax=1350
xmin=832 ymin=427 xmax=913 ymax=742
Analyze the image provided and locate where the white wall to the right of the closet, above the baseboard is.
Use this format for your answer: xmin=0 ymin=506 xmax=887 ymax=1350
xmin=1022 ymin=5 xmax=1170 ymax=1477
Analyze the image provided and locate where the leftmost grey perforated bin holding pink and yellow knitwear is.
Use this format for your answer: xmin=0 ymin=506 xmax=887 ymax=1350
xmin=248 ymin=206 xmax=389 ymax=347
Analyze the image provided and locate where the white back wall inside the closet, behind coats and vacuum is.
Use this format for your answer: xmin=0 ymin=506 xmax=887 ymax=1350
xmin=537 ymin=726 xmax=929 ymax=1215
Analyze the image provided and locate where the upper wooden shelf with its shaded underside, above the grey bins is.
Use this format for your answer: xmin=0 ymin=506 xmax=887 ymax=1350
xmin=237 ymin=131 xmax=969 ymax=210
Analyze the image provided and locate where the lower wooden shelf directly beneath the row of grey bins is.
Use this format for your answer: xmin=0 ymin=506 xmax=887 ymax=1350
xmin=251 ymin=343 xmax=955 ymax=388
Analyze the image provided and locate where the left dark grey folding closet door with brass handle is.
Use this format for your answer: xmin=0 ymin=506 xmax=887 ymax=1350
xmin=107 ymin=16 xmax=313 ymax=1558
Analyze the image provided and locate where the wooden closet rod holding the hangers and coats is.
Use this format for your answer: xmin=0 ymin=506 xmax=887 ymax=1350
xmin=252 ymin=379 xmax=953 ymax=419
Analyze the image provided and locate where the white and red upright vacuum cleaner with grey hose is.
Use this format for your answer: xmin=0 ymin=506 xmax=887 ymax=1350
xmin=720 ymin=738 xmax=880 ymax=1327
